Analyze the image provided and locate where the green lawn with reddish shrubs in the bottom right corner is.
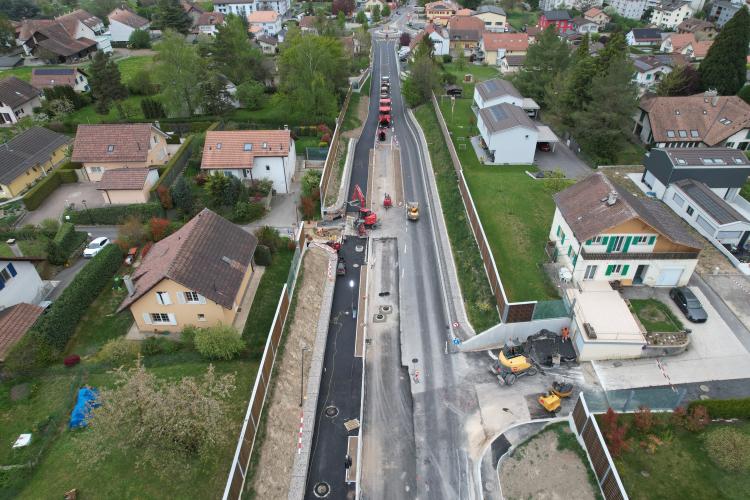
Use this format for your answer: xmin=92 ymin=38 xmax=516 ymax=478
xmin=600 ymin=417 xmax=750 ymax=500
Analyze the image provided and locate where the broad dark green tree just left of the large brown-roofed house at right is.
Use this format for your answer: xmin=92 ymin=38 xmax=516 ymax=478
xmin=574 ymin=59 xmax=637 ymax=163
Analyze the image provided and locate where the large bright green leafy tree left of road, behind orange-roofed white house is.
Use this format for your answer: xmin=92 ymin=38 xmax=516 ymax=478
xmin=279 ymin=34 xmax=349 ymax=122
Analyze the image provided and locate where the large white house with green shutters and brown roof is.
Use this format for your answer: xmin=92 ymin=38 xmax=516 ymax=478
xmin=549 ymin=172 xmax=702 ymax=286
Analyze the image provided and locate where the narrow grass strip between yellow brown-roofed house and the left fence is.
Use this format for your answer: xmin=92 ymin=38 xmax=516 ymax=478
xmin=242 ymin=248 xmax=294 ymax=361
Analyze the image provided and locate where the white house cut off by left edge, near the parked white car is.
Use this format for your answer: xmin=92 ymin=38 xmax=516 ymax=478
xmin=0 ymin=257 xmax=45 ymax=310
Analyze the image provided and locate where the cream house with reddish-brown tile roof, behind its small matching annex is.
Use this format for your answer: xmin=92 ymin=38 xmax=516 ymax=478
xmin=70 ymin=123 xmax=169 ymax=182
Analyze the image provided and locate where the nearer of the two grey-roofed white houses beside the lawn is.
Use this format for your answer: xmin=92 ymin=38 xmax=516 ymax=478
xmin=477 ymin=102 xmax=539 ymax=165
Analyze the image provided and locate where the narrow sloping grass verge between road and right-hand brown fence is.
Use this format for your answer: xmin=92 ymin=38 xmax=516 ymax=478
xmin=414 ymin=104 xmax=500 ymax=332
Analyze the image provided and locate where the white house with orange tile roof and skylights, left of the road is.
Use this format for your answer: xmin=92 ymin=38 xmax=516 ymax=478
xmin=201 ymin=129 xmax=297 ymax=193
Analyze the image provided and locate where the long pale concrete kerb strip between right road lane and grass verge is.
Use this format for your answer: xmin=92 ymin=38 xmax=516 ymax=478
xmin=406 ymin=109 xmax=476 ymax=338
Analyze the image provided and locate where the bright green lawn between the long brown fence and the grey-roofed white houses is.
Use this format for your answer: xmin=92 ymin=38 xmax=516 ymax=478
xmin=441 ymin=93 xmax=567 ymax=302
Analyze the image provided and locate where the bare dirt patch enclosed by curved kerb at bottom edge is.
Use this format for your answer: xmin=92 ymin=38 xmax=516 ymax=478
xmin=500 ymin=430 xmax=596 ymax=500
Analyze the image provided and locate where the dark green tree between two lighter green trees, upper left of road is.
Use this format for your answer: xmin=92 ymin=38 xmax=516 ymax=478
xmin=211 ymin=15 xmax=268 ymax=85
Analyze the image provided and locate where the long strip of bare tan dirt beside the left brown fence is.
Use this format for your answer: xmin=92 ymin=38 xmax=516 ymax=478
xmin=252 ymin=247 xmax=329 ymax=498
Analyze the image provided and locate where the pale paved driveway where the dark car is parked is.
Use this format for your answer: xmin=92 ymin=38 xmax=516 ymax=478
xmin=592 ymin=286 xmax=750 ymax=390
